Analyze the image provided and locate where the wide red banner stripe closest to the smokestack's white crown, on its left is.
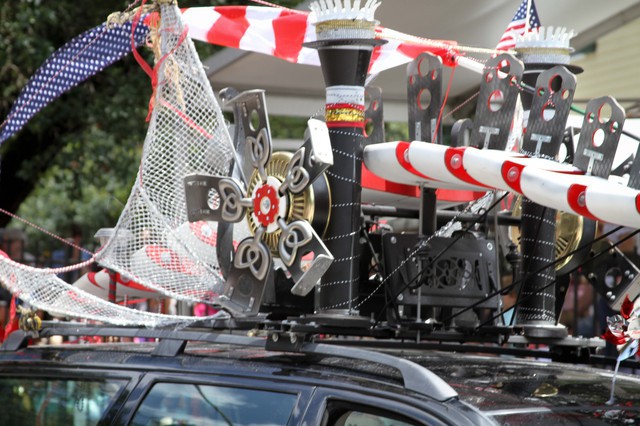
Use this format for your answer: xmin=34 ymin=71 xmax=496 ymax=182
xmin=273 ymin=10 xmax=307 ymax=62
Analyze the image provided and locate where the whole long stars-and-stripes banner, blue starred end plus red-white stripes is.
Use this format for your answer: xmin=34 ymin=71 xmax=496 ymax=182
xmin=0 ymin=6 xmax=457 ymax=144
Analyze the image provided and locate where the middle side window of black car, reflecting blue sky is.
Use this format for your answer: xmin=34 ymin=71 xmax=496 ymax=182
xmin=131 ymin=383 xmax=298 ymax=426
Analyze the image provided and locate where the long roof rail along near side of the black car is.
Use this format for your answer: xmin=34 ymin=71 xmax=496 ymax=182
xmin=0 ymin=321 xmax=458 ymax=401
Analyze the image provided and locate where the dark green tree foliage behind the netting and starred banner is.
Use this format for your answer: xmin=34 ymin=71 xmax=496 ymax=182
xmin=0 ymin=0 xmax=299 ymax=253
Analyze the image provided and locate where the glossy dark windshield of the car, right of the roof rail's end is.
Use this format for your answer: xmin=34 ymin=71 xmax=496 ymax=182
xmin=413 ymin=355 xmax=640 ymax=426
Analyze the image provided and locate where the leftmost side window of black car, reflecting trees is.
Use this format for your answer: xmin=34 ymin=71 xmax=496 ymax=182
xmin=0 ymin=377 xmax=127 ymax=426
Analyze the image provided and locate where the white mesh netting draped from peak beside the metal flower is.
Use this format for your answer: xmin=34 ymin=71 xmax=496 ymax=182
xmin=0 ymin=5 xmax=248 ymax=326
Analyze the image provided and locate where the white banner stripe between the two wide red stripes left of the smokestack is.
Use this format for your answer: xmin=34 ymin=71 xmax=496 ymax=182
xmin=239 ymin=6 xmax=281 ymax=55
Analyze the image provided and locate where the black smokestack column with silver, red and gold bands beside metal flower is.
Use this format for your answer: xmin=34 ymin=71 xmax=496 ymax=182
xmin=313 ymin=40 xmax=377 ymax=314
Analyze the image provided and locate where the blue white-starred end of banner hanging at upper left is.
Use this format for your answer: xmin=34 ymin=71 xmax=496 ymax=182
xmin=0 ymin=22 xmax=149 ymax=144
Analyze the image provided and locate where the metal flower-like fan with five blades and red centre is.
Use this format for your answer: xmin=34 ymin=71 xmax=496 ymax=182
xmin=185 ymin=90 xmax=333 ymax=315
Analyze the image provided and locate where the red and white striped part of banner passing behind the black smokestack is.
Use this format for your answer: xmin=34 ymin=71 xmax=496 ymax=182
xmin=170 ymin=6 xmax=458 ymax=74
